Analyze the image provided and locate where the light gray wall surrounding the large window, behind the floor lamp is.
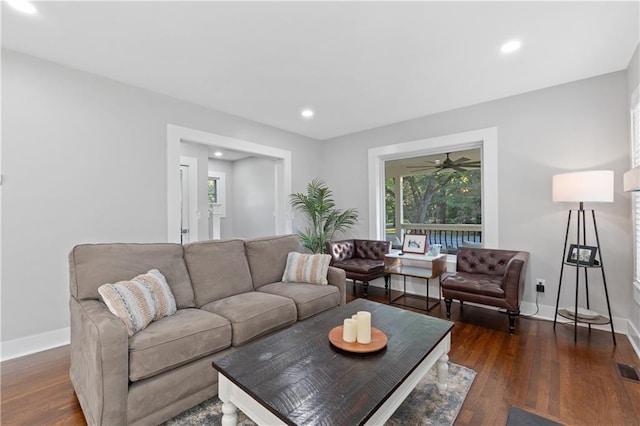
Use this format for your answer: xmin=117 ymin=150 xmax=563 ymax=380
xmin=323 ymin=71 xmax=632 ymax=318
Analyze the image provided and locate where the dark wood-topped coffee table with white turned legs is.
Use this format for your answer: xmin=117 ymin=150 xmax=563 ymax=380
xmin=213 ymin=299 xmax=453 ymax=426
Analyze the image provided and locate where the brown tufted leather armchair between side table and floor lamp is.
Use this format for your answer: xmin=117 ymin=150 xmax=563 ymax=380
xmin=442 ymin=247 xmax=529 ymax=334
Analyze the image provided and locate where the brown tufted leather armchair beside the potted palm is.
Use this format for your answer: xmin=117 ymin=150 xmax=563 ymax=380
xmin=326 ymin=240 xmax=391 ymax=297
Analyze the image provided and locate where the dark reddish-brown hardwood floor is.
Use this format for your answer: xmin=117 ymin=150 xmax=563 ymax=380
xmin=0 ymin=283 xmax=640 ymax=425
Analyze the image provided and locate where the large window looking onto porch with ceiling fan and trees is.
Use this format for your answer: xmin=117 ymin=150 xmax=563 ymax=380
xmin=385 ymin=148 xmax=482 ymax=253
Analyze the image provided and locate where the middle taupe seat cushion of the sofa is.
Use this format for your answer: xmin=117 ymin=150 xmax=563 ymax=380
xmin=201 ymin=291 xmax=297 ymax=346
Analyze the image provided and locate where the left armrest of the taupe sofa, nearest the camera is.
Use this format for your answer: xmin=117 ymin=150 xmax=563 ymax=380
xmin=69 ymin=297 xmax=129 ymax=425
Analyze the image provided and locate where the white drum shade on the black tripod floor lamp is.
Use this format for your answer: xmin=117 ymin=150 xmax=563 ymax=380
xmin=553 ymin=170 xmax=613 ymax=203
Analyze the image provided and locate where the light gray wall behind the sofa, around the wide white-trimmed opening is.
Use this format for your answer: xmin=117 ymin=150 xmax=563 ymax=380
xmin=1 ymin=49 xmax=322 ymax=349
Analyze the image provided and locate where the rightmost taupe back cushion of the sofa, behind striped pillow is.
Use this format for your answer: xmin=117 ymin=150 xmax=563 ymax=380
xmin=244 ymin=235 xmax=300 ymax=289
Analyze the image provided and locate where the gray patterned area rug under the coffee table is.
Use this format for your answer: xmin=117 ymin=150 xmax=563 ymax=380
xmin=164 ymin=362 xmax=476 ymax=426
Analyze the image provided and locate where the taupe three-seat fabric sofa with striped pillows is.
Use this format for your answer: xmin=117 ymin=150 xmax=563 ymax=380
xmin=69 ymin=235 xmax=345 ymax=425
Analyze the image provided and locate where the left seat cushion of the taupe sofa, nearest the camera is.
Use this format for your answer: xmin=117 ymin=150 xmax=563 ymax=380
xmin=129 ymin=309 xmax=231 ymax=382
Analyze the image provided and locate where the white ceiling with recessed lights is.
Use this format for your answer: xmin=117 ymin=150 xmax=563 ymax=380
xmin=2 ymin=1 xmax=640 ymax=140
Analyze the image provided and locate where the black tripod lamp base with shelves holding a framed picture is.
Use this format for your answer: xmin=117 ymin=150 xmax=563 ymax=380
xmin=553 ymin=202 xmax=616 ymax=346
